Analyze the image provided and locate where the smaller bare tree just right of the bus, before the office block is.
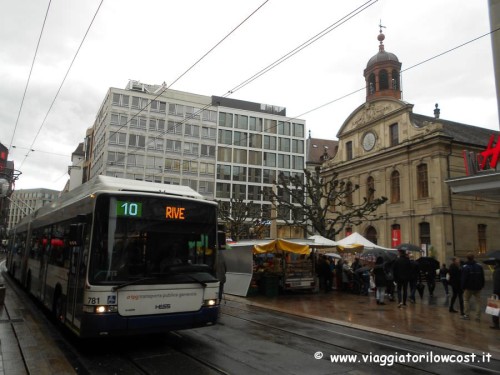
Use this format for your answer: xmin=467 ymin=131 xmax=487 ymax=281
xmin=217 ymin=198 xmax=261 ymax=241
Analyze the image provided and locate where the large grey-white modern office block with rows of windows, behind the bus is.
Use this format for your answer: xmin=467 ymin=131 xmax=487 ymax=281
xmin=83 ymin=81 xmax=306 ymax=235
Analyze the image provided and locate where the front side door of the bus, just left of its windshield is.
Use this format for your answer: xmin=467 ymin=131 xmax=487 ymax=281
xmin=66 ymin=223 xmax=85 ymax=327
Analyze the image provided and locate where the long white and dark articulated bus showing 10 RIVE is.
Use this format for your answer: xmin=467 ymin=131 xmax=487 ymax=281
xmin=7 ymin=176 xmax=219 ymax=338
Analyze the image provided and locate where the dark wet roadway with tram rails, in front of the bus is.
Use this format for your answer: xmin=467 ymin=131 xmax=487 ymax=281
xmin=51 ymin=301 xmax=500 ymax=375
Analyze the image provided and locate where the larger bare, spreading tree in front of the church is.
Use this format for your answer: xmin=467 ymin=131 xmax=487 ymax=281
xmin=267 ymin=168 xmax=387 ymax=239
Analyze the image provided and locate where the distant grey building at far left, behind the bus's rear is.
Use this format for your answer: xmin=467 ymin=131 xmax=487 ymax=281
xmin=7 ymin=188 xmax=61 ymax=230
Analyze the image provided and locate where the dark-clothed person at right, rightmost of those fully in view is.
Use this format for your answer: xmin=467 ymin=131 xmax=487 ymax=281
xmin=462 ymin=253 xmax=484 ymax=321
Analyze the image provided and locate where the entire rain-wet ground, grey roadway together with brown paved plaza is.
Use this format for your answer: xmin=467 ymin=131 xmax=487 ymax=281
xmin=0 ymin=264 xmax=500 ymax=375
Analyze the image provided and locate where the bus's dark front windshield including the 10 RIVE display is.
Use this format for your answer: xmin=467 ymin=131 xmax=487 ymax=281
xmin=89 ymin=194 xmax=217 ymax=284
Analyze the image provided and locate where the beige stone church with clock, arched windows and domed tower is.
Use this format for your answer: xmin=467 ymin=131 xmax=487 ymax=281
xmin=322 ymin=33 xmax=500 ymax=262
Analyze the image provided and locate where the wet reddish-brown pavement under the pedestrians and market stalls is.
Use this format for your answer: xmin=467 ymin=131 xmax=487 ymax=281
xmin=225 ymin=284 xmax=500 ymax=360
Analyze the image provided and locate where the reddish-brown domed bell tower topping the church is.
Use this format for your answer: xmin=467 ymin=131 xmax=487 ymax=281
xmin=364 ymin=25 xmax=401 ymax=102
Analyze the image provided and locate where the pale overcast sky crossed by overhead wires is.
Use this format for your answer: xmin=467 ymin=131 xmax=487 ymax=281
xmin=0 ymin=0 xmax=499 ymax=190
